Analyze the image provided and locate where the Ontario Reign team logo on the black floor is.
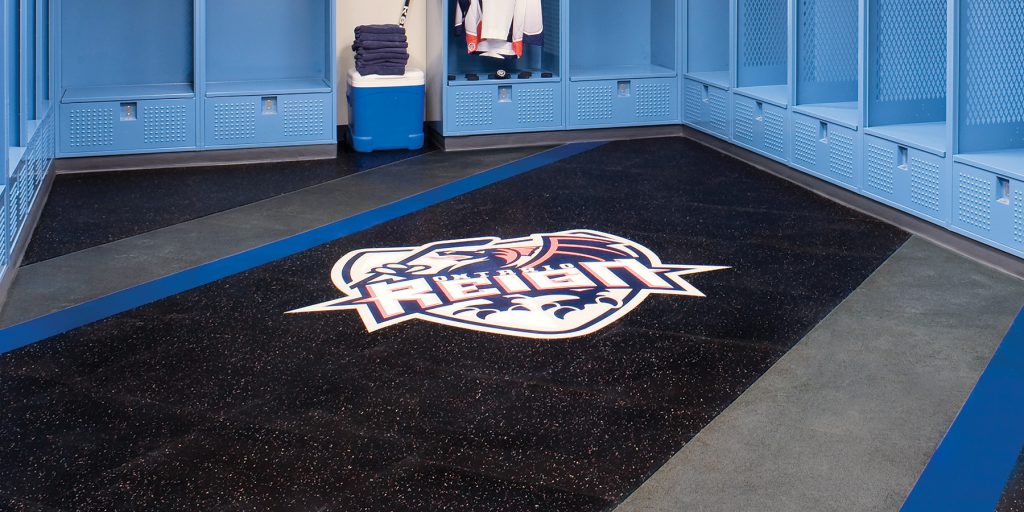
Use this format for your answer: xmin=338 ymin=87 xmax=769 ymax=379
xmin=290 ymin=229 xmax=728 ymax=339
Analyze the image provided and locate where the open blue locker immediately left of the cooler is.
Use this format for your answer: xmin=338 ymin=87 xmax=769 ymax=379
xmin=201 ymin=0 xmax=337 ymax=148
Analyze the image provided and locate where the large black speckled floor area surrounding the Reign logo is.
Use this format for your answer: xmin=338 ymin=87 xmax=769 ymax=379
xmin=0 ymin=138 xmax=907 ymax=511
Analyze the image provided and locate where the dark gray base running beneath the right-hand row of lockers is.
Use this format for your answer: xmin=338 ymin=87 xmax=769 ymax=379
xmin=683 ymin=127 xmax=1024 ymax=279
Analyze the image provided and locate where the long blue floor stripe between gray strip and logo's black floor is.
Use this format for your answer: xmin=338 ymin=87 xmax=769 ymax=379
xmin=0 ymin=142 xmax=604 ymax=353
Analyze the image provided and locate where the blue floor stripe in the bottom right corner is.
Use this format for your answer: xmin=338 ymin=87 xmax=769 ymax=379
xmin=902 ymin=305 xmax=1024 ymax=512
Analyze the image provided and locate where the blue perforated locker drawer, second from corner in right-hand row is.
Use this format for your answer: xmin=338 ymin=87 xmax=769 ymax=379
xmin=732 ymin=94 xmax=790 ymax=161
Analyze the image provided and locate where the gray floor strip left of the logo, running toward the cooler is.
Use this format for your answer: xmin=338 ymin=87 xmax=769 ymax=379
xmin=0 ymin=147 xmax=547 ymax=328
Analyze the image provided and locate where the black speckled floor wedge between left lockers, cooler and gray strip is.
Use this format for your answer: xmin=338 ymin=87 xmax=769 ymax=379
xmin=23 ymin=144 xmax=432 ymax=265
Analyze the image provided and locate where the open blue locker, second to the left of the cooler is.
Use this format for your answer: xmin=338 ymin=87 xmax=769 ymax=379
xmin=57 ymin=0 xmax=199 ymax=157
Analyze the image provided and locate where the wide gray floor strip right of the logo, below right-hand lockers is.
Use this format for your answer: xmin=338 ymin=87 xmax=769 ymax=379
xmin=617 ymin=238 xmax=1024 ymax=512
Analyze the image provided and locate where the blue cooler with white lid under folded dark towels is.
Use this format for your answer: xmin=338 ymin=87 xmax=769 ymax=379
xmin=348 ymin=69 xmax=425 ymax=153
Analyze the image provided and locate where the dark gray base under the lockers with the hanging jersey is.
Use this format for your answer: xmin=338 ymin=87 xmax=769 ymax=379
xmin=427 ymin=124 xmax=683 ymax=152
